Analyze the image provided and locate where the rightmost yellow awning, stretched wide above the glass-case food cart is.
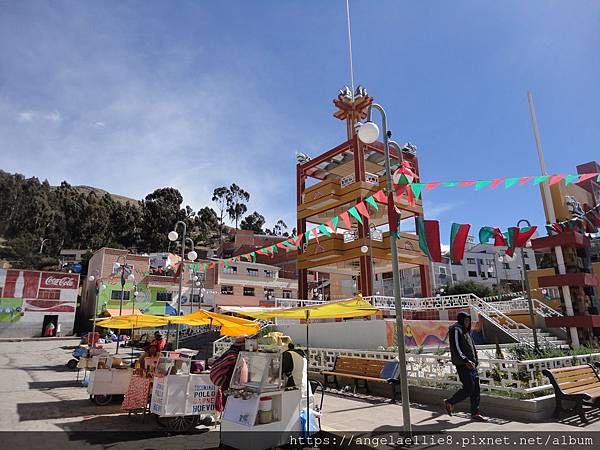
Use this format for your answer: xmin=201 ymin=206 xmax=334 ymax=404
xmin=240 ymin=295 xmax=379 ymax=319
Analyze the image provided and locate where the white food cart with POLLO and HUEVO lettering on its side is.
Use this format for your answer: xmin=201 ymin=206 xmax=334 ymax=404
xmin=150 ymin=355 xmax=217 ymax=432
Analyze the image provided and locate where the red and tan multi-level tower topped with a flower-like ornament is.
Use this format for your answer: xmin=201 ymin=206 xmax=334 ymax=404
xmin=296 ymin=86 xmax=431 ymax=300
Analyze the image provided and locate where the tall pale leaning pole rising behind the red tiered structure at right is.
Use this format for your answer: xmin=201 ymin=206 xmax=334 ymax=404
xmin=527 ymin=92 xmax=579 ymax=348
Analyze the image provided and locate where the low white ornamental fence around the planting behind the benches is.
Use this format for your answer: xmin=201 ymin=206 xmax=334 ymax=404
xmin=309 ymin=348 xmax=600 ymax=395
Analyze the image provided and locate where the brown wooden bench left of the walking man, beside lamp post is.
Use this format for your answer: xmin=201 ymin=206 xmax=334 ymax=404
xmin=321 ymin=356 xmax=400 ymax=403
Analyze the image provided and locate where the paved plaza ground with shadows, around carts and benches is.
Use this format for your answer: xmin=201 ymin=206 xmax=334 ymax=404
xmin=0 ymin=339 xmax=600 ymax=448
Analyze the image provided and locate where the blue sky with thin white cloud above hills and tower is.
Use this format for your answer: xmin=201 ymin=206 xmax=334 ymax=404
xmin=0 ymin=0 xmax=600 ymax=241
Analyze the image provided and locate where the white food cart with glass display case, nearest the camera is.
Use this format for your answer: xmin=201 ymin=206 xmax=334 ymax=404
xmin=221 ymin=351 xmax=302 ymax=450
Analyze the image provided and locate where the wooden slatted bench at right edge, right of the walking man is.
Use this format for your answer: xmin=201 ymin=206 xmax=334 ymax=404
xmin=542 ymin=364 xmax=600 ymax=422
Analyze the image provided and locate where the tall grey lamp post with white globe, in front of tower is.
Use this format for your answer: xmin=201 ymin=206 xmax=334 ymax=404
xmin=358 ymin=103 xmax=411 ymax=434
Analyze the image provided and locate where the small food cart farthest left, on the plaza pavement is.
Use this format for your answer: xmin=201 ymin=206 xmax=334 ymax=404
xmin=87 ymin=355 xmax=133 ymax=406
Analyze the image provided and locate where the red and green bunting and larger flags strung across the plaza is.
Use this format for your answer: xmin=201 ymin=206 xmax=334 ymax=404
xmin=170 ymin=165 xmax=600 ymax=278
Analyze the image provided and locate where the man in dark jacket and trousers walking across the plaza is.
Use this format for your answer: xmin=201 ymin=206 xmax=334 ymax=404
xmin=444 ymin=311 xmax=487 ymax=422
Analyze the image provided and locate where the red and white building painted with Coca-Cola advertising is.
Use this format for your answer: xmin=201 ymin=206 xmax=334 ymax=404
xmin=0 ymin=269 xmax=79 ymax=337
